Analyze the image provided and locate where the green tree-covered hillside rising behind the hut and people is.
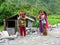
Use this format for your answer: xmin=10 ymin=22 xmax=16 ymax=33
xmin=0 ymin=0 xmax=60 ymax=24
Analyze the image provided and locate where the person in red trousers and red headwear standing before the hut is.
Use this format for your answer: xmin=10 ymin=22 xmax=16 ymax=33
xmin=19 ymin=11 xmax=26 ymax=36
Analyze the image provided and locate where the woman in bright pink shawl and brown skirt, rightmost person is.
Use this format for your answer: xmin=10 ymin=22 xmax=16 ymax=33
xmin=41 ymin=11 xmax=47 ymax=35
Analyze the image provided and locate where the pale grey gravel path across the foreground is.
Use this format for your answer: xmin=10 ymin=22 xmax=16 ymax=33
xmin=0 ymin=25 xmax=60 ymax=45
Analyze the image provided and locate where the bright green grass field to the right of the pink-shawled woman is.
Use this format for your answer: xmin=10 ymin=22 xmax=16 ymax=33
xmin=48 ymin=15 xmax=60 ymax=25
